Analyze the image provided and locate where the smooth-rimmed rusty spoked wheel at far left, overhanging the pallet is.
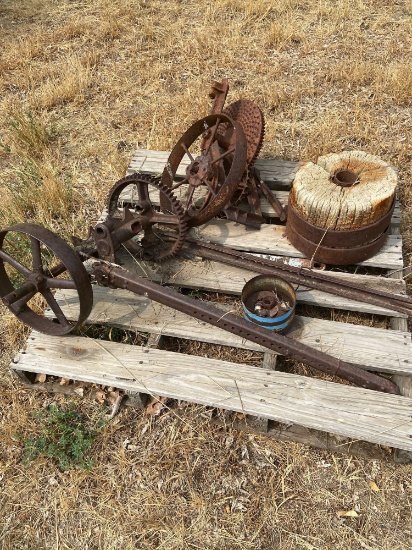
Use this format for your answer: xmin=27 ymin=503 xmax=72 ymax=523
xmin=0 ymin=223 xmax=93 ymax=336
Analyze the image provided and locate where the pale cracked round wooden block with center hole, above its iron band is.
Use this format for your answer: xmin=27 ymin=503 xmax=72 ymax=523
xmin=289 ymin=151 xmax=398 ymax=231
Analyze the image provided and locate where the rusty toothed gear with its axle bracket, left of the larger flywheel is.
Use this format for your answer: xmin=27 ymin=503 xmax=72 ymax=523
xmin=102 ymin=173 xmax=188 ymax=261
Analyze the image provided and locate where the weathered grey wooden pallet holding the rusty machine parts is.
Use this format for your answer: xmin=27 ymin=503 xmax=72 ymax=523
xmin=12 ymin=150 xmax=412 ymax=460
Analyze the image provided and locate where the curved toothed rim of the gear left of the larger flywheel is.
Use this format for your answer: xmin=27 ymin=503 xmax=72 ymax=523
xmin=106 ymin=172 xmax=189 ymax=262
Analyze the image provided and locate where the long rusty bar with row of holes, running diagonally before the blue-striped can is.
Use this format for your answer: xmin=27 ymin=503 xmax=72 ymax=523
xmin=93 ymin=263 xmax=399 ymax=394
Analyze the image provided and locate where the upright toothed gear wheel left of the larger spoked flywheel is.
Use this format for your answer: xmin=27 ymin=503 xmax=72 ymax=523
xmin=106 ymin=172 xmax=189 ymax=262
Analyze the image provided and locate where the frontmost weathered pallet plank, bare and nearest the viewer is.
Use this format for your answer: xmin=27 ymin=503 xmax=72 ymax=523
xmin=12 ymin=332 xmax=412 ymax=450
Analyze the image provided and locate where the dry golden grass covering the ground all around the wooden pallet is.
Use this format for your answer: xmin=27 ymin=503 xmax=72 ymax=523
xmin=0 ymin=0 xmax=412 ymax=550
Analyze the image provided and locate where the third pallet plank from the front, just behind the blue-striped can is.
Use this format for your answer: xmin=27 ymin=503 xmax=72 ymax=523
xmin=115 ymin=252 xmax=401 ymax=316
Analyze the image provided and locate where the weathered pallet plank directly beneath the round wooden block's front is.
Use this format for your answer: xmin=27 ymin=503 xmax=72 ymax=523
xmin=190 ymin=219 xmax=403 ymax=269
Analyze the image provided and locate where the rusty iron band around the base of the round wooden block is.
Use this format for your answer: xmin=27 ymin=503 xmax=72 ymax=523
xmin=286 ymin=201 xmax=395 ymax=265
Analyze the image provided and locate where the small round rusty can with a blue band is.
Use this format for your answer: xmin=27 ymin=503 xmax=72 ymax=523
xmin=241 ymin=275 xmax=296 ymax=332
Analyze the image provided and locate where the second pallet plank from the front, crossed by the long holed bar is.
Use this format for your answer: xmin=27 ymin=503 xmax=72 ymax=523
xmin=51 ymin=286 xmax=412 ymax=374
